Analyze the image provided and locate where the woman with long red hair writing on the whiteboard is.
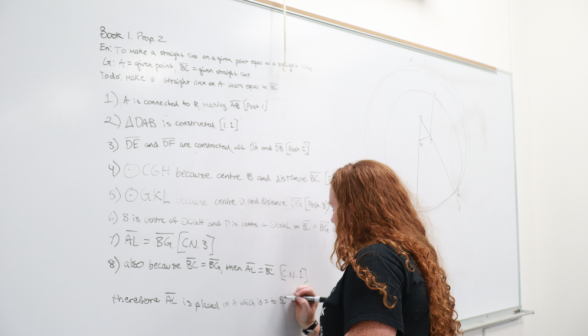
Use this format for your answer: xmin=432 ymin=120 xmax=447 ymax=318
xmin=294 ymin=160 xmax=461 ymax=336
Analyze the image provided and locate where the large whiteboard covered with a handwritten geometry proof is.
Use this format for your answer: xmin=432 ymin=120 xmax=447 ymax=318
xmin=0 ymin=0 xmax=520 ymax=335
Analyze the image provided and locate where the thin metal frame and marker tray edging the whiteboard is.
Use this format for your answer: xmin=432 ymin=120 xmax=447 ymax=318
xmin=235 ymin=0 xmax=535 ymax=332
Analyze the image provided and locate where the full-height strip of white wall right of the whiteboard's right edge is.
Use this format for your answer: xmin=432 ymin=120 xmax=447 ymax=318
xmin=510 ymin=0 xmax=588 ymax=335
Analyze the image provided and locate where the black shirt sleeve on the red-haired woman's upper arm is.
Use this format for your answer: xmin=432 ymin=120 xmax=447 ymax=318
xmin=342 ymin=244 xmax=406 ymax=335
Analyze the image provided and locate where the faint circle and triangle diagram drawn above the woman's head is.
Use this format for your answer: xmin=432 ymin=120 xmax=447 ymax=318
xmin=366 ymin=65 xmax=466 ymax=211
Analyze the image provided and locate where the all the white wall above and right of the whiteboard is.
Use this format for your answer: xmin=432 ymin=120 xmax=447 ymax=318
xmin=287 ymin=0 xmax=588 ymax=336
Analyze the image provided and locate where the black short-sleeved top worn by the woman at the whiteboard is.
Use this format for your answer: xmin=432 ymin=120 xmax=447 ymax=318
xmin=320 ymin=244 xmax=429 ymax=336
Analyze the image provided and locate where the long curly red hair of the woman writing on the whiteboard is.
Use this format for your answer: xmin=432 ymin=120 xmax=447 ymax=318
xmin=331 ymin=160 xmax=461 ymax=336
